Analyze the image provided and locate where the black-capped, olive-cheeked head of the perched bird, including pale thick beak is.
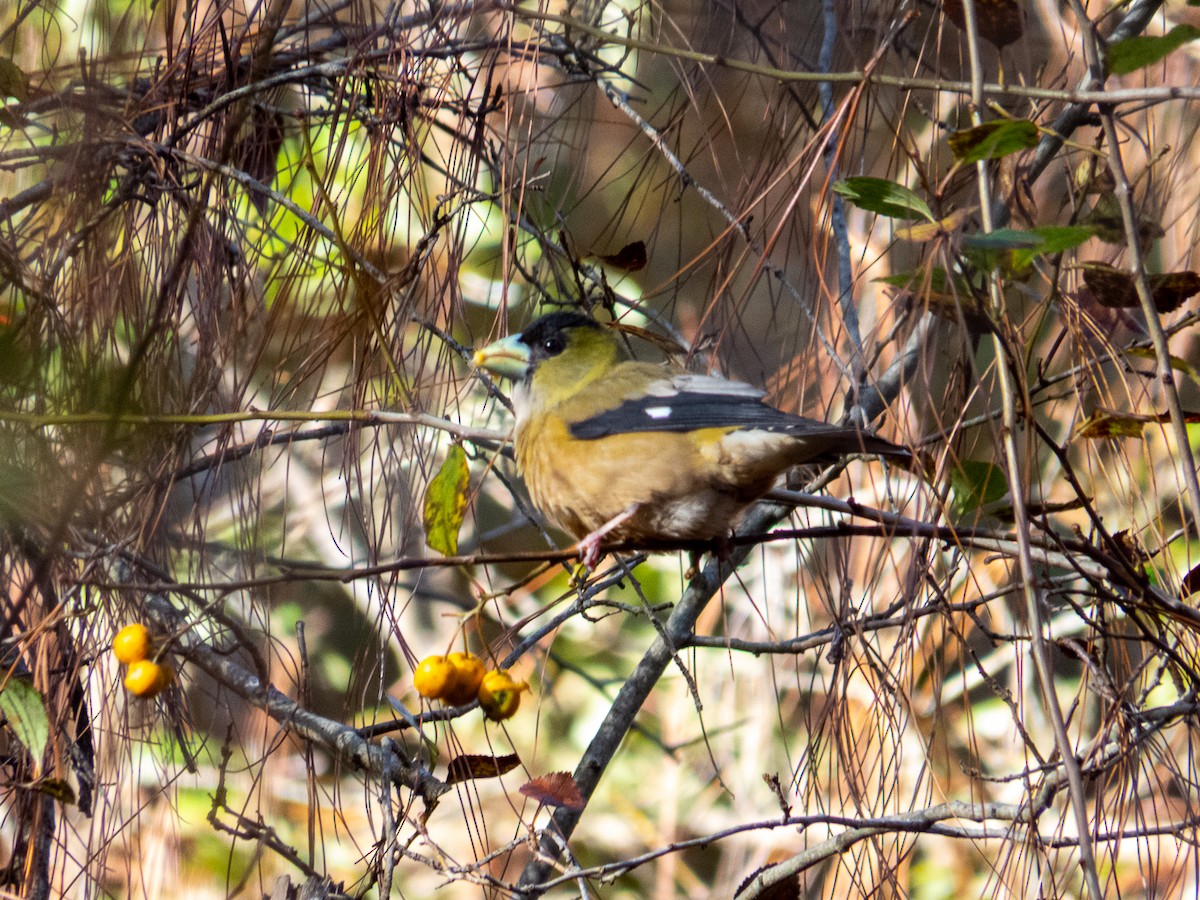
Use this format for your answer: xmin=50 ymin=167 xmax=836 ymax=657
xmin=474 ymin=312 xmax=624 ymax=404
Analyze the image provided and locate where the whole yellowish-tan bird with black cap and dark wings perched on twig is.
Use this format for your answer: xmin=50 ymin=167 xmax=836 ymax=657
xmin=473 ymin=311 xmax=912 ymax=569
